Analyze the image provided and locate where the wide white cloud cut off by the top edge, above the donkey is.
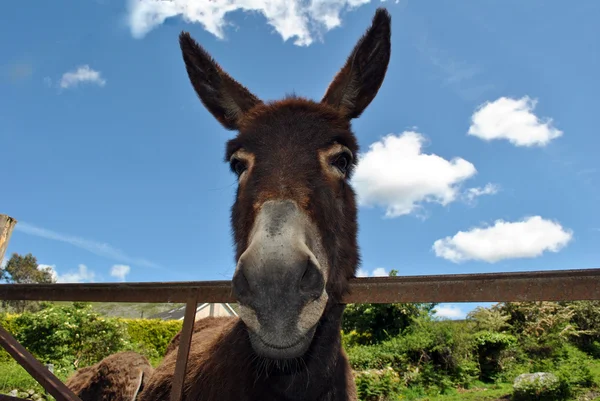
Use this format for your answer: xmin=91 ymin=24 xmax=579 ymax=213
xmin=127 ymin=0 xmax=371 ymax=46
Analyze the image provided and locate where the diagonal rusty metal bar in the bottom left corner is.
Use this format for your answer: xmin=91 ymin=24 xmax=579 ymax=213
xmin=0 ymin=325 xmax=81 ymax=401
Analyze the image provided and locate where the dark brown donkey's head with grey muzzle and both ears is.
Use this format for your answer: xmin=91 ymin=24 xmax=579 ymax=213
xmin=179 ymin=9 xmax=391 ymax=359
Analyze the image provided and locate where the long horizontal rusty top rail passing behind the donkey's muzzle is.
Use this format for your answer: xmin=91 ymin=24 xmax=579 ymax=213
xmin=0 ymin=269 xmax=600 ymax=303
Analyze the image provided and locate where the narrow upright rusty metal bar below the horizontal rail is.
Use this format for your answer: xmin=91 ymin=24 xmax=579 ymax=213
xmin=171 ymin=296 xmax=198 ymax=401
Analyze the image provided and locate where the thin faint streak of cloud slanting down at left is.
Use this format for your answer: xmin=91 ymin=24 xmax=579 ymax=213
xmin=15 ymin=222 xmax=159 ymax=268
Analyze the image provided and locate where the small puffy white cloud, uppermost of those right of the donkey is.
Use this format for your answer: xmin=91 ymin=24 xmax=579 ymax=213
xmin=468 ymin=96 xmax=563 ymax=146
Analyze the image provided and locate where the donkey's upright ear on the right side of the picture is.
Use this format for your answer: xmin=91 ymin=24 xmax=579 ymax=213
xmin=321 ymin=8 xmax=391 ymax=119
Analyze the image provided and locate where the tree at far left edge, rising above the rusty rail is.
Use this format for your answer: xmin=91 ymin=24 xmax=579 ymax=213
xmin=0 ymin=253 xmax=56 ymax=313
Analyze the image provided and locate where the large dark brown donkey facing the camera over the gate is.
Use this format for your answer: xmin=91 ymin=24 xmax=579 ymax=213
xmin=138 ymin=8 xmax=391 ymax=401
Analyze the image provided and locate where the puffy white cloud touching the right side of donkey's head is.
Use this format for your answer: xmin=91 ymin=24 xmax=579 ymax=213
xmin=352 ymin=131 xmax=477 ymax=218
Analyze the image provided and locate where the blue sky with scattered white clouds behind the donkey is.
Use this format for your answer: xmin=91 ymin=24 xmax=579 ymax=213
xmin=0 ymin=0 xmax=600 ymax=317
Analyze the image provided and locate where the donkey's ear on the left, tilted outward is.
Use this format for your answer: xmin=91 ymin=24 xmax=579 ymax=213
xmin=179 ymin=32 xmax=262 ymax=130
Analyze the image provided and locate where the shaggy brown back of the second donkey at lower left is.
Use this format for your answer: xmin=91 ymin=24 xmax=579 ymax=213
xmin=65 ymin=351 xmax=154 ymax=401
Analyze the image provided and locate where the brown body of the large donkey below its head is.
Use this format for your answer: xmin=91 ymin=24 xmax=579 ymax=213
xmin=138 ymin=306 xmax=357 ymax=401
